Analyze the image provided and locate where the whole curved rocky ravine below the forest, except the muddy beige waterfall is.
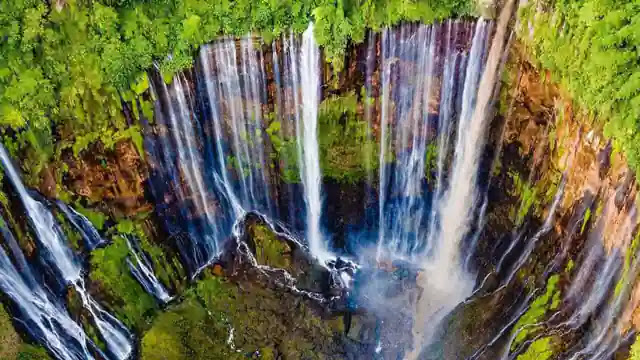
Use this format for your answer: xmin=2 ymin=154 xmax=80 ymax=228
xmin=0 ymin=12 xmax=640 ymax=360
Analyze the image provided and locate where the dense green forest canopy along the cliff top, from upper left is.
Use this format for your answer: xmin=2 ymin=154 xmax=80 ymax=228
xmin=0 ymin=0 xmax=474 ymax=184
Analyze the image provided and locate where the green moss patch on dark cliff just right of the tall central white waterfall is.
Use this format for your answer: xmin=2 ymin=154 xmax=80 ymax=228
xmin=318 ymin=92 xmax=379 ymax=183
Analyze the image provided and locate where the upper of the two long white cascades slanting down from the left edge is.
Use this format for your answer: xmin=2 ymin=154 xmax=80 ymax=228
xmin=0 ymin=145 xmax=133 ymax=360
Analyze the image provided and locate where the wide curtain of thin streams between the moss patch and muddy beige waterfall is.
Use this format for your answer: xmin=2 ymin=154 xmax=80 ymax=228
xmin=377 ymin=20 xmax=489 ymax=260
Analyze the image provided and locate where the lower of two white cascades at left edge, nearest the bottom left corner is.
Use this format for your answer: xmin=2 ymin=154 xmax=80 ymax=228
xmin=0 ymin=219 xmax=95 ymax=360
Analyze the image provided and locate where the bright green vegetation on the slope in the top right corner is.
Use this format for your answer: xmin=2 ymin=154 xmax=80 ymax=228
xmin=520 ymin=0 xmax=640 ymax=174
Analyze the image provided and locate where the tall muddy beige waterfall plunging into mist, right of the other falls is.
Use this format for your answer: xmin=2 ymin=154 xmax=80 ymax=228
xmin=407 ymin=0 xmax=514 ymax=359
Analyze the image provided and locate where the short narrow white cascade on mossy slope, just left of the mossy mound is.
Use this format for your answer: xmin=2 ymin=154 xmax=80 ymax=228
xmin=125 ymin=236 xmax=172 ymax=304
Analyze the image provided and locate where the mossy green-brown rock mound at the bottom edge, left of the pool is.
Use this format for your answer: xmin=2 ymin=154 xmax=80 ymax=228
xmin=141 ymin=277 xmax=343 ymax=360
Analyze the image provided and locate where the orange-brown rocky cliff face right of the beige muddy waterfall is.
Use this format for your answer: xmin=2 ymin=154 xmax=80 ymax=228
xmin=442 ymin=44 xmax=638 ymax=359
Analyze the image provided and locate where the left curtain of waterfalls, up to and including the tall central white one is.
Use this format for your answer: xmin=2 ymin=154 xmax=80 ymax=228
xmin=145 ymin=25 xmax=327 ymax=274
